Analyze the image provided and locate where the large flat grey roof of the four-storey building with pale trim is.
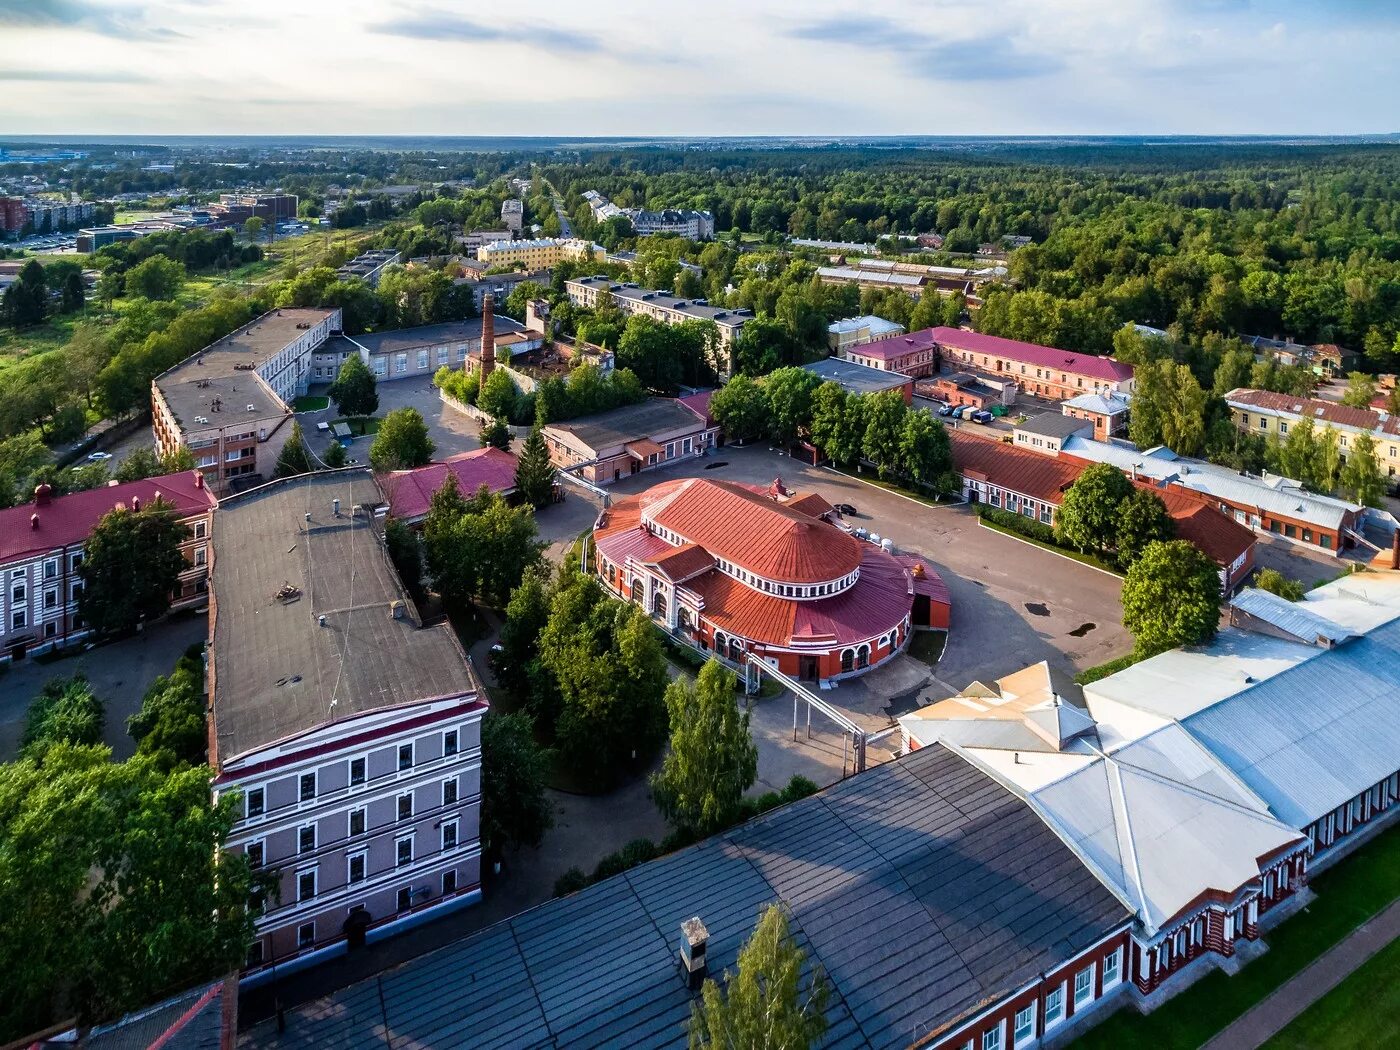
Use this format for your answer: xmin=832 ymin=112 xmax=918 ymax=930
xmin=213 ymin=469 xmax=476 ymax=762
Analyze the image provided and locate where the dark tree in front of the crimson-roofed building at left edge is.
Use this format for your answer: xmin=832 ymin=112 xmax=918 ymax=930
xmin=78 ymin=500 xmax=189 ymax=634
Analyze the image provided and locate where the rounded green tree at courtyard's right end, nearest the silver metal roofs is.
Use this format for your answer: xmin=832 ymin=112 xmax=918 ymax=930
xmin=1121 ymin=539 xmax=1221 ymax=657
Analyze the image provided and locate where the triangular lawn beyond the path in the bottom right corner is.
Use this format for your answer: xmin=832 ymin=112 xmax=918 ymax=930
xmin=1264 ymin=941 xmax=1400 ymax=1050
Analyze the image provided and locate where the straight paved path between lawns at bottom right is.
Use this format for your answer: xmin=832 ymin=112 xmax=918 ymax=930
xmin=1201 ymin=900 xmax=1400 ymax=1050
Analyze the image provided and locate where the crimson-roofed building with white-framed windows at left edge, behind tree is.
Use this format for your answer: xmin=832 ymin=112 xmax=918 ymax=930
xmin=0 ymin=470 xmax=214 ymax=659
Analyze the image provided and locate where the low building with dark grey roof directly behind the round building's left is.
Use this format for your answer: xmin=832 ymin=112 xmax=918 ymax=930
xmin=543 ymin=398 xmax=720 ymax=484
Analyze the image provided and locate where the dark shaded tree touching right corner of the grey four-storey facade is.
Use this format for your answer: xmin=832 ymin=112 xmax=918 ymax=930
xmin=482 ymin=711 xmax=554 ymax=860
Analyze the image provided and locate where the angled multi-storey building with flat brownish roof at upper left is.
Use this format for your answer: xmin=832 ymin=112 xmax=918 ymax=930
xmin=151 ymin=307 xmax=340 ymax=496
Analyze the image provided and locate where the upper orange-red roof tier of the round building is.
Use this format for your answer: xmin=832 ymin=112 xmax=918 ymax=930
xmin=640 ymin=477 xmax=861 ymax=584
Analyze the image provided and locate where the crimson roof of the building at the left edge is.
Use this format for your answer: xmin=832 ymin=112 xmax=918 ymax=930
xmin=0 ymin=470 xmax=216 ymax=563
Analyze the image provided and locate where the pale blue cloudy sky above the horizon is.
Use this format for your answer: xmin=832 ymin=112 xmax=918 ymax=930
xmin=0 ymin=0 xmax=1400 ymax=136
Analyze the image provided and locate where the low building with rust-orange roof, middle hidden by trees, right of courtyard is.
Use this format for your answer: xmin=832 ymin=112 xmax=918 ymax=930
xmin=948 ymin=428 xmax=1257 ymax=594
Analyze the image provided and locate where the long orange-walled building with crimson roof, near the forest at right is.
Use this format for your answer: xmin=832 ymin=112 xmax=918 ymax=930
xmin=930 ymin=328 xmax=1133 ymax=400
